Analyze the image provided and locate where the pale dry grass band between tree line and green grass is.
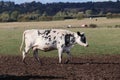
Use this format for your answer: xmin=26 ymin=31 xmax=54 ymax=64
xmin=0 ymin=18 xmax=120 ymax=28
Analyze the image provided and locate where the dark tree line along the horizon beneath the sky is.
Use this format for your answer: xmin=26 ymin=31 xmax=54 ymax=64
xmin=0 ymin=0 xmax=120 ymax=22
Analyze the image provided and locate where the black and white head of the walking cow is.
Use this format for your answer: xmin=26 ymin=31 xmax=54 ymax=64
xmin=75 ymin=32 xmax=88 ymax=47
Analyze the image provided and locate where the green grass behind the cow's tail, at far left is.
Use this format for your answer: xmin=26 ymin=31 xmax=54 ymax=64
xmin=0 ymin=29 xmax=21 ymax=54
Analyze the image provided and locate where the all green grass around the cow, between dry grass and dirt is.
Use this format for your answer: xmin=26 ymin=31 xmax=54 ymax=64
xmin=0 ymin=28 xmax=120 ymax=56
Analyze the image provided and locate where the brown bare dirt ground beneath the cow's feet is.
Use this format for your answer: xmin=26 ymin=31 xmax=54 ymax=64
xmin=0 ymin=55 xmax=120 ymax=80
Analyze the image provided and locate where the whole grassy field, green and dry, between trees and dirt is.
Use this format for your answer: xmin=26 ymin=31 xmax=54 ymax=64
xmin=0 ymin=18 xmax=120 ymax=56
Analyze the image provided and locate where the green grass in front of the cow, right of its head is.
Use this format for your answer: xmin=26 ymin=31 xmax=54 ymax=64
xmin=73 ymin=28 xmax=120 ymax=55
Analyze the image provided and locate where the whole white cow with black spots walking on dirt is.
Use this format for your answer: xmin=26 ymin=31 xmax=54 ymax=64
xmin=20 ymin=29 xmax=88 ymax=63
